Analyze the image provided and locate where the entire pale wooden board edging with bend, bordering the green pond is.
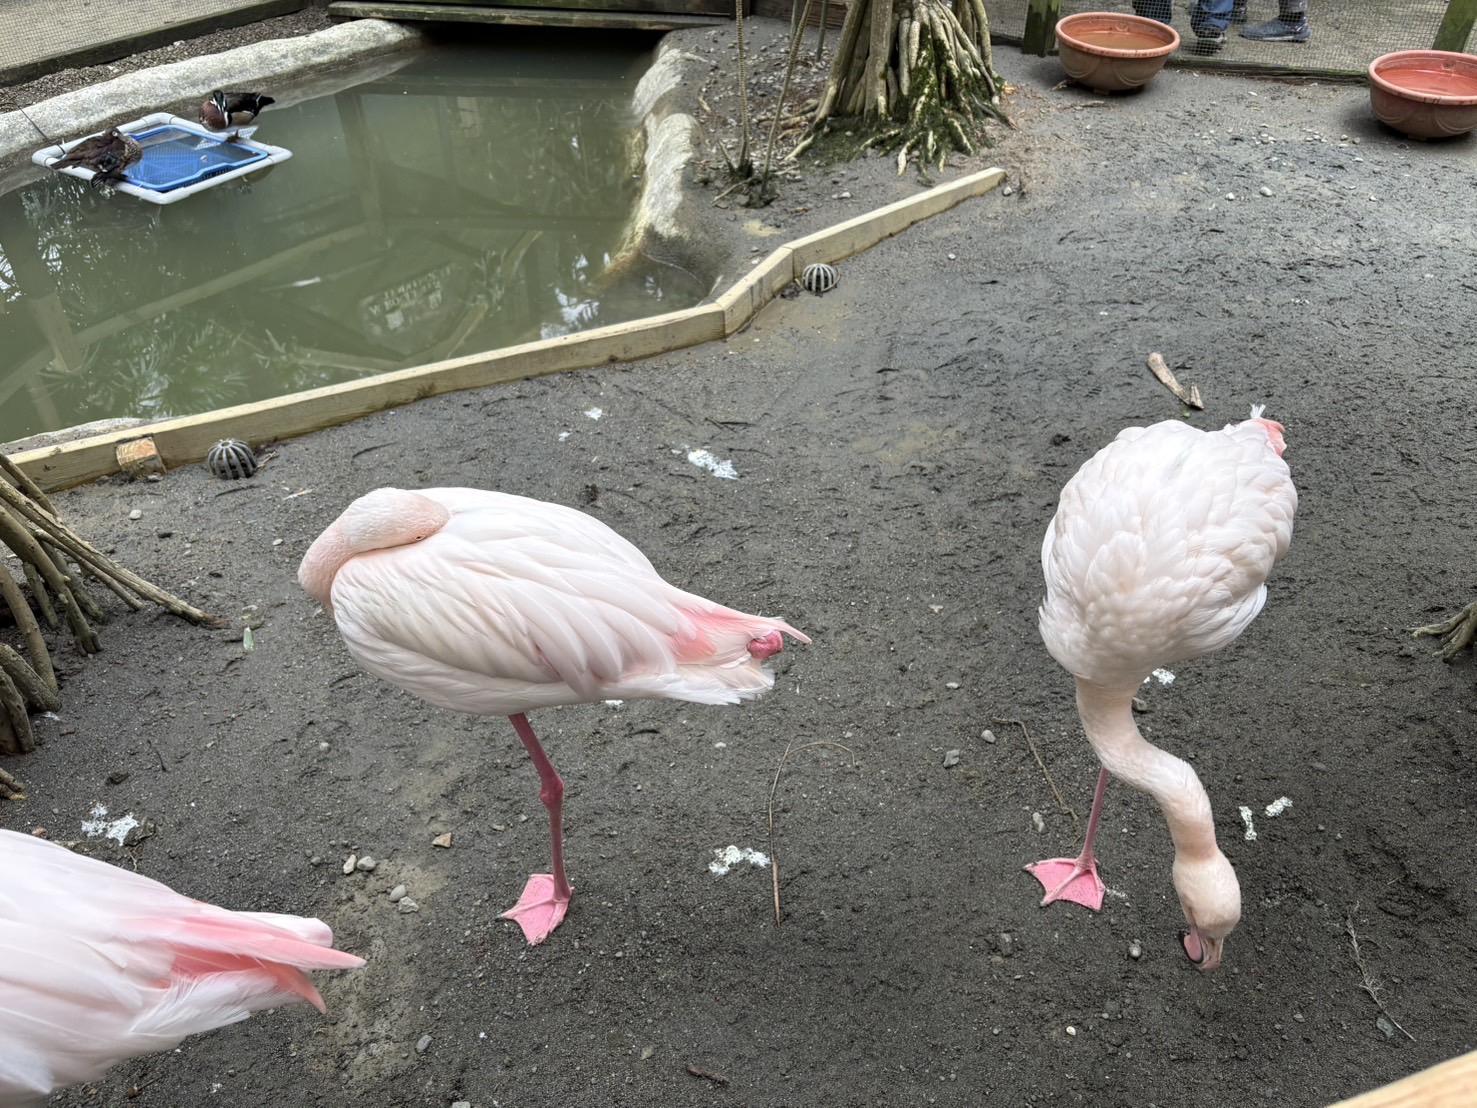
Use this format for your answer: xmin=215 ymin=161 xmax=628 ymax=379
xmin=10 ymin=168 xmax=1006 ymax=490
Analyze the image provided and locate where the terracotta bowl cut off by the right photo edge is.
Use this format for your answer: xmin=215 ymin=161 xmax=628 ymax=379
xmin=1369 ymin=50 xmax=1477 ymax=139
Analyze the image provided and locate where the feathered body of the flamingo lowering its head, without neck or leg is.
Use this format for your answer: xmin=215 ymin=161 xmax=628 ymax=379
xmin=1040 ymin=420 xmax=1297 ymax=685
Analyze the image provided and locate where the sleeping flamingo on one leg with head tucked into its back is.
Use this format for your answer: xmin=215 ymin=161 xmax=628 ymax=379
xmin=298 ymin=489 xmax=809 ymax=944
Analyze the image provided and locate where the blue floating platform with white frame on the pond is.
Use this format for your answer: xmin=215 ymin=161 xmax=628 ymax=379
xmin=31 ymin=112 xmax=292 ymax=204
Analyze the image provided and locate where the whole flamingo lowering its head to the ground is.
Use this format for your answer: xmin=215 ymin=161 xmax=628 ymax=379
xmin=1027 ymin=408 xmax=1297 ymax=971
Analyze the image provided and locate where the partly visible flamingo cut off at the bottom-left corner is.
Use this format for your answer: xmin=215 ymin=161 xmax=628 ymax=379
xmin=0 ymin=830 xmax=363 ymax=1108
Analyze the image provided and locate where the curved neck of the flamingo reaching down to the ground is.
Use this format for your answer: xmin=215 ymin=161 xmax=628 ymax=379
xmin=1077 ymin=678 xmax=1220 ymax=861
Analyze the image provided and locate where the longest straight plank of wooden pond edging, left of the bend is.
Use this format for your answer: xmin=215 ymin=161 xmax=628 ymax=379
xmin=10 ymin=304 xmax=724 ymax=490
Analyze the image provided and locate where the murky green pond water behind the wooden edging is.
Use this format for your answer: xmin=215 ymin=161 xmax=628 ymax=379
xmin=0 ymin=37 xmax=703 ymax=442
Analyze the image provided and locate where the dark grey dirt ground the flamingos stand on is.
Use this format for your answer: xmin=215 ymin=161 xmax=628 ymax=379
xmin=0 ymin=15 xmax=1477 ymax=1108
